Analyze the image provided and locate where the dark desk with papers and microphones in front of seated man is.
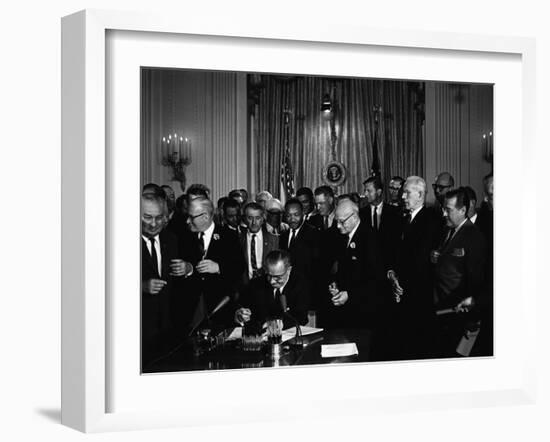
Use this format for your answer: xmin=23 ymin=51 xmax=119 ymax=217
xmin=143 ymin=329 xmax=372 ymax=373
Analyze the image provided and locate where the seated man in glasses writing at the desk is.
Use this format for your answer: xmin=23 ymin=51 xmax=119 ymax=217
xmin=234 ymin=250 xmax=309 ymax=328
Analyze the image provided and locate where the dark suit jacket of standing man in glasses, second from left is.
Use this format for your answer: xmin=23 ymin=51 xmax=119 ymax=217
xmin=177 ymin=226 xmax=244 ymax=330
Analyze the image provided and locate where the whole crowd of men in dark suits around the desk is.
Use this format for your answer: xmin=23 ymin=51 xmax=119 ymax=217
xmin=141 ymin=172 xmax=493 ymax=364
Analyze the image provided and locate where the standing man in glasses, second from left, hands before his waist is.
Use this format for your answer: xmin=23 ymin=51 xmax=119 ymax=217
xmin=173 ymin=196 xmax=244 ymax=332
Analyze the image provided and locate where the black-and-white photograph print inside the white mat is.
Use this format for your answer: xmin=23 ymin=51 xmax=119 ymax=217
xmin=136 ymin=67 xmax=494 ymax=373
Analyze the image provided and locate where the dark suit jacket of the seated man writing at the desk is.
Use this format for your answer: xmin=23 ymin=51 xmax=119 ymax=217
xmin=241 ymin=268 xmax=309 ymax=328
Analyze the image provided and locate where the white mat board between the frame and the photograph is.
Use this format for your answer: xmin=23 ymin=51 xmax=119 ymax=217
xmin=108 ymin=28 xmax=528 ymax=419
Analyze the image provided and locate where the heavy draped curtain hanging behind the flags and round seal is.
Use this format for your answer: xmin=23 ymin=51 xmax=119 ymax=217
xmin=249 ymin=75 xmax=424 ymax=196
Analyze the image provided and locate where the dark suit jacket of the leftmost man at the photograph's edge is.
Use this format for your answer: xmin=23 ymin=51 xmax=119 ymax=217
xmin=141 ymin=230 xmax=178 ymax=361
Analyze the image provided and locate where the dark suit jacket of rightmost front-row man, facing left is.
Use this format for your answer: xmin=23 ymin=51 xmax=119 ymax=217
xmin=435 ymin=220 xmax=486 ymax=309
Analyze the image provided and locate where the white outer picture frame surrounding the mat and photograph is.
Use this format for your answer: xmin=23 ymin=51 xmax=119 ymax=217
xmin=62 ymin=10 xmax=537 ymax=432
